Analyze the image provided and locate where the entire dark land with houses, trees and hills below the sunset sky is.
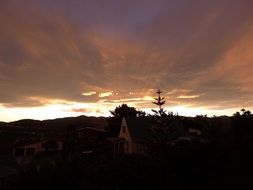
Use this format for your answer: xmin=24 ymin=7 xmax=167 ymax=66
xmin=0 ymin=91 xmax=253 ymax=189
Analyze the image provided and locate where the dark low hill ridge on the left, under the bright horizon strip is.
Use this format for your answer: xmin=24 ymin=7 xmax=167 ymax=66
xmin=9 ymin=115 xmax=107 ymax=129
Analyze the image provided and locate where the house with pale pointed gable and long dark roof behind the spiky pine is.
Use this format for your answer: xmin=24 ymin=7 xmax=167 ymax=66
xmin=117 ymin=117 xmax=204 ymax=154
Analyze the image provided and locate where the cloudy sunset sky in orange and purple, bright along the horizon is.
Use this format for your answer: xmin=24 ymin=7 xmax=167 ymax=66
xmin=0 ymin=0 xmax=253 ymax=121
